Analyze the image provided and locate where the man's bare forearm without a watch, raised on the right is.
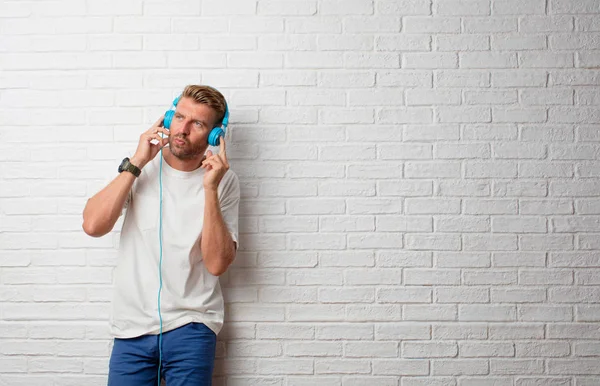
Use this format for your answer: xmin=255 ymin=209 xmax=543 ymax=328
xmin=200 ymin=190 xmax=235 ymax=276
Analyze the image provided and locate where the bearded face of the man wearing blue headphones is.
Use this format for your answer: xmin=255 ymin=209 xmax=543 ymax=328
xmin=169 ymin=98 xmax=217 ymax=160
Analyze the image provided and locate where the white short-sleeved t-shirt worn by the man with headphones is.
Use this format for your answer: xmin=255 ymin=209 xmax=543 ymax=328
xmin=110 ymin=153 xmax=240 ymax=338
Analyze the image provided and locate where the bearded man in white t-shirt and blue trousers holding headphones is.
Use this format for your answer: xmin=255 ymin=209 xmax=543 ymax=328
xmin=83 ymin=85 xmax=240 ymax=386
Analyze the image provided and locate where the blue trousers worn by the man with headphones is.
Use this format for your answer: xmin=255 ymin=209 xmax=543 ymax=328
xmin=108 ymin=323 xmax=217 ymax=386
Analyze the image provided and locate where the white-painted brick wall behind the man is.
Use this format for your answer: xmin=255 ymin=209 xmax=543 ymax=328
xmin=0 ymin=0 xmax=600 ymax=386
